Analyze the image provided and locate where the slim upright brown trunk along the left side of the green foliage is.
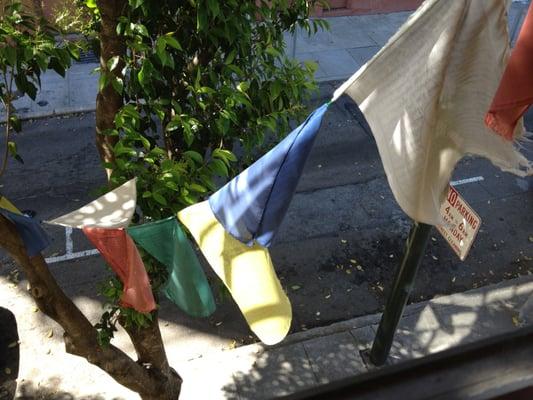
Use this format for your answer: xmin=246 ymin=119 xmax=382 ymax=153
xmin=96 ymin=0 xmax=127 ymax=178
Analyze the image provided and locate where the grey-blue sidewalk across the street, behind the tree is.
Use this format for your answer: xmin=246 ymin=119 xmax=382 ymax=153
xmin=0 ymin=1 xmax=528 ymax=119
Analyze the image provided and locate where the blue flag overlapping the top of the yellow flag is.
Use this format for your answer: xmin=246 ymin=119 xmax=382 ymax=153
xmin=209 ymin=104 xmax=328 ymax=247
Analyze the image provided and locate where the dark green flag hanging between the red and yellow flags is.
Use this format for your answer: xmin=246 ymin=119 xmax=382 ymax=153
xmin=127 ymin=217 xmax=215 ymax=317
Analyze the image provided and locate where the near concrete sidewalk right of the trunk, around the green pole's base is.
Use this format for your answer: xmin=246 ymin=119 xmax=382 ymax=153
xmin=176 ymin=276 xmax=533 ymax=400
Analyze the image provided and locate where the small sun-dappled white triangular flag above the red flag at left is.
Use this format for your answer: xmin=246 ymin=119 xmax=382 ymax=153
xmin=45 ymin=178 xmax=137 ymax=229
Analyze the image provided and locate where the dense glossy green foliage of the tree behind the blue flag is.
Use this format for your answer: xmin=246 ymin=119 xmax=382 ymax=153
xmin=100 ymin=0 xmax=325 ymax=219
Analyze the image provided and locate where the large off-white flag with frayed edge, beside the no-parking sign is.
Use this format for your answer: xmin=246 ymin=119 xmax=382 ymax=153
xmin=332 ymin=0 xmax=532 ymax=225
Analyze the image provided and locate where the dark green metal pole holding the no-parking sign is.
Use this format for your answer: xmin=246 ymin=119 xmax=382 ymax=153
xmin=370 ymin=222 xmax=431 ymax=365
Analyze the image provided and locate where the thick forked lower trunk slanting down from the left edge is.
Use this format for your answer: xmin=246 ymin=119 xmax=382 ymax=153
xmin=0 ymin=215 xmax=181 ymax=400
